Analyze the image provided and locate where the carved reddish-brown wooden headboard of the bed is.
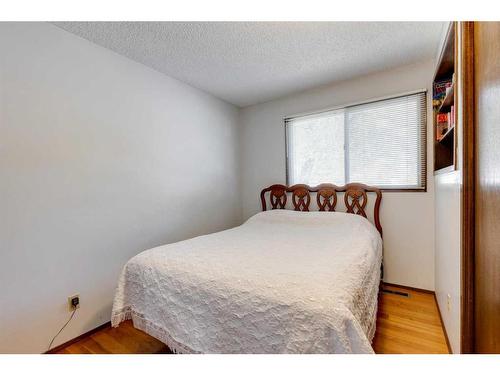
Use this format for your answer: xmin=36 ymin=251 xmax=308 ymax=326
xmin=260 ymin=183 xmax=382 ymax=236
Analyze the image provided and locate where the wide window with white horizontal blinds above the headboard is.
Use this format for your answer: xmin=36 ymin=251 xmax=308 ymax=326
xmin=285 ymin=92 xmax=427 ymax=190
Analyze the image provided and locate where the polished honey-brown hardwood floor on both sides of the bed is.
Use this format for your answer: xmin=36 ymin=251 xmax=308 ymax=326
xmin=50 ymin=286 xmax=448 ymax=354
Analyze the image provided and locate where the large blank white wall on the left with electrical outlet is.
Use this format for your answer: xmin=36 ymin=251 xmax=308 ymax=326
xmin=0 ymin=23 xmax=241 ymax=353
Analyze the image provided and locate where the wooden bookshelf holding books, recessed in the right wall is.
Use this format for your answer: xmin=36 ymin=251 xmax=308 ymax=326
xmin=432 ymin=22 xmax=457 ymax=172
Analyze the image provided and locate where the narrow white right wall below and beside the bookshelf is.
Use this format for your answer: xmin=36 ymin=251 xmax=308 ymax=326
xmin=434 ymin=24 xmax=463 ymax=353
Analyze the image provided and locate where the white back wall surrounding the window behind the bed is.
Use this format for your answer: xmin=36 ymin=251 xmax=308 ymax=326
xmin=240 ymin=61 xmax=434 ymax=290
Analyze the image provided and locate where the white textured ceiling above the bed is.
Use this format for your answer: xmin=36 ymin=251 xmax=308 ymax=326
xmin=55 ymin=22 xmax=444 ymax=107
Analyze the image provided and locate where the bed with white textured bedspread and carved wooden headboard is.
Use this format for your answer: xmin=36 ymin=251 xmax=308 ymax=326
xmin=111 ymin=184 xmax=382 ymax=353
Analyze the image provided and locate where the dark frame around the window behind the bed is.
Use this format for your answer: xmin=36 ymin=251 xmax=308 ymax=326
xmin=282 ymin=89 xmax=428 ymax=193
